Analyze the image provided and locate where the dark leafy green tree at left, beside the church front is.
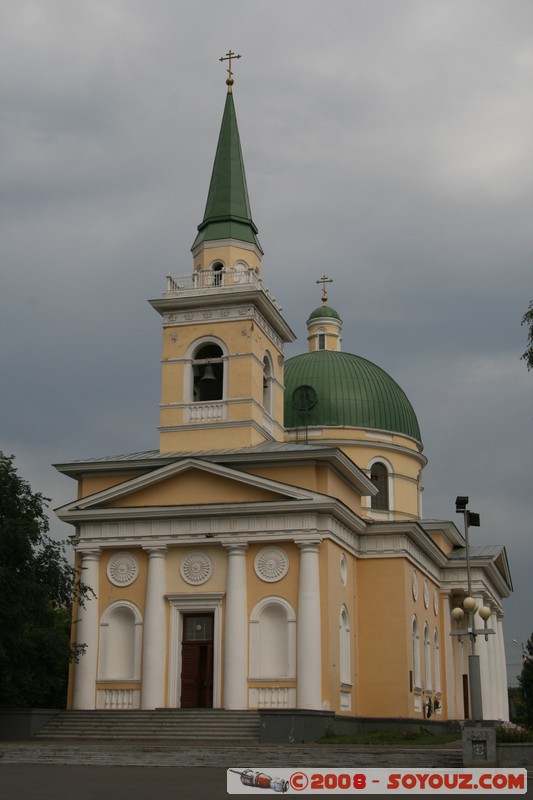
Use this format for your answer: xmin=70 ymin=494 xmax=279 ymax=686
xmin=0 ymin=451 xmax=87 ymax=707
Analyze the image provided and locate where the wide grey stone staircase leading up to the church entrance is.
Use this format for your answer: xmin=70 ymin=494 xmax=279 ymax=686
xmin=35 ymin=708 xmax=259 ymax=743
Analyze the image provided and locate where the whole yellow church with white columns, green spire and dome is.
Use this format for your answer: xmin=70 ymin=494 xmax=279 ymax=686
xmin=56 ymin=60 xmax=512 ymax=721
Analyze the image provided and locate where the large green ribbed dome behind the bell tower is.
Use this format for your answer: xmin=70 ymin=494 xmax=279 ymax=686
xmin=285 ymin=350 xmax=421 ymax=443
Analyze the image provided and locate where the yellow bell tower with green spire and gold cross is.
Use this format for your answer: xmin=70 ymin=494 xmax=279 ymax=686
xmin=150 ymin=56 xmax=295 ymax=453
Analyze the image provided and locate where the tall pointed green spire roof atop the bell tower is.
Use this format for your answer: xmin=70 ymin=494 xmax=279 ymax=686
xmin=191 ymin=87 xmax=263 ymax=253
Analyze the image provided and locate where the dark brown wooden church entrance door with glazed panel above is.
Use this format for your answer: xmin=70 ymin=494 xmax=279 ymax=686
xmin=180 ymin=614 xmax=214 ymax=708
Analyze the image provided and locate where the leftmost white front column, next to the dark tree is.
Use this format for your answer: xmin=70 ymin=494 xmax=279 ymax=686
xmin=72 ymin=549 xmax=100 ymax=709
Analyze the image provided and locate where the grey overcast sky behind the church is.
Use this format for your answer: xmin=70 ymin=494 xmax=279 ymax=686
xmin=0 ymin=0 xmax=533 ymax=679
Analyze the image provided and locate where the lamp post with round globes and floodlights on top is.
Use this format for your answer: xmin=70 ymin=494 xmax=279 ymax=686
xmin=451 ymin=496 xmax=495 ymax=721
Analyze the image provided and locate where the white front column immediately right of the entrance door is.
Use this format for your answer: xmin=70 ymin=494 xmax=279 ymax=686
xmin=224 ymin=544 xmax=248 ymax=709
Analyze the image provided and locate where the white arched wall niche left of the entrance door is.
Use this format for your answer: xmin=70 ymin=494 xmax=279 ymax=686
xmin=98 ymin=600 xmax=142 ymax=680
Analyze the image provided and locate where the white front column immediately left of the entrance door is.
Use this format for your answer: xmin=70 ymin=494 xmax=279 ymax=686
xmin=141 ymin=547 xmax=167 ymax=709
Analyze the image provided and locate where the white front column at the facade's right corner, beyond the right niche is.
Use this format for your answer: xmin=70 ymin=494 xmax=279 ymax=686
xmin=296 ymin=542 xmax=322 ymax=709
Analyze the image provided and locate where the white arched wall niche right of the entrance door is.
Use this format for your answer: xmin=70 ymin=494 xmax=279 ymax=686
xmin=250 ymin=597 xmax=296 ymax=680
